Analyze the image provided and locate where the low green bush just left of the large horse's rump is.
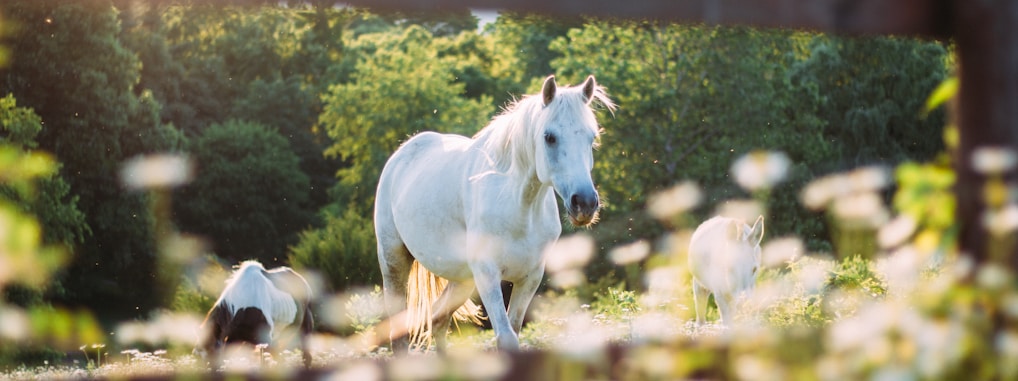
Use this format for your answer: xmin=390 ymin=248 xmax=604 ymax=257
xmin=289 ymin=209 xmax=382 ymax=291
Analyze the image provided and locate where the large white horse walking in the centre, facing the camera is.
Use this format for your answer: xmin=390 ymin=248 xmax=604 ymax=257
xmin=375 ymin=75 xmax=615 ymax=352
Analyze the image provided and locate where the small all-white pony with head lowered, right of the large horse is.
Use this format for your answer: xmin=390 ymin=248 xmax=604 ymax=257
xmin=689 ymin=216 xmax=764 ymax=324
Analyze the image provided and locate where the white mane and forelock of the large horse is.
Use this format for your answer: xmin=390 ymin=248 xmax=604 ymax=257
xmin=473 ymin=80 xmax=615 ymax=175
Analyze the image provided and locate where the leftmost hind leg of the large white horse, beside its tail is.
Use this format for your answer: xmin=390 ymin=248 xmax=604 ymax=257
xmin=378 ymin=233 xmax=413 ymax=353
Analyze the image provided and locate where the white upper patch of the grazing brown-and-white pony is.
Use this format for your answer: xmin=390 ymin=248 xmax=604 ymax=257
xmin=216 ymin=261 xmax=297 ymax=329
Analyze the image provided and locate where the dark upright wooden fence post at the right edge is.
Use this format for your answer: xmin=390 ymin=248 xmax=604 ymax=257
xmin=952 ymin=0 xmax=1018 ymax=269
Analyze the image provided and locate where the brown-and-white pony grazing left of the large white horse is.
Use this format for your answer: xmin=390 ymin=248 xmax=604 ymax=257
xmin=194 ymin=261 xmax=315 ymax=367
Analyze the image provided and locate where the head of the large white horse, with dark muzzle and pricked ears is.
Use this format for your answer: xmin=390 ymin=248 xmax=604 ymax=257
xmin=534 ymin=75 xmax=614 ymax=226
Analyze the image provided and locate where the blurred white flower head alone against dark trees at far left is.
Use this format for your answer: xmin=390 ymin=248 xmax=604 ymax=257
xmin=120 ymin=155 xmax=193 ymax=189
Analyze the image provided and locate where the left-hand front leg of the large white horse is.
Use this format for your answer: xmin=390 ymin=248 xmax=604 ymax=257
xmin=470 ymin=261 xmax=519 ymax=350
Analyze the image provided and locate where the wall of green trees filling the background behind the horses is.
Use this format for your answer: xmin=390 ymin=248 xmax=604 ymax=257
xmin=0 ymin=0 xmax=950 ymax=317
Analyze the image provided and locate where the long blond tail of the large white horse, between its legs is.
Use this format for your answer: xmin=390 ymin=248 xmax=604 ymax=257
xmin=406 ymin=261 xmax=482 ymax=347
